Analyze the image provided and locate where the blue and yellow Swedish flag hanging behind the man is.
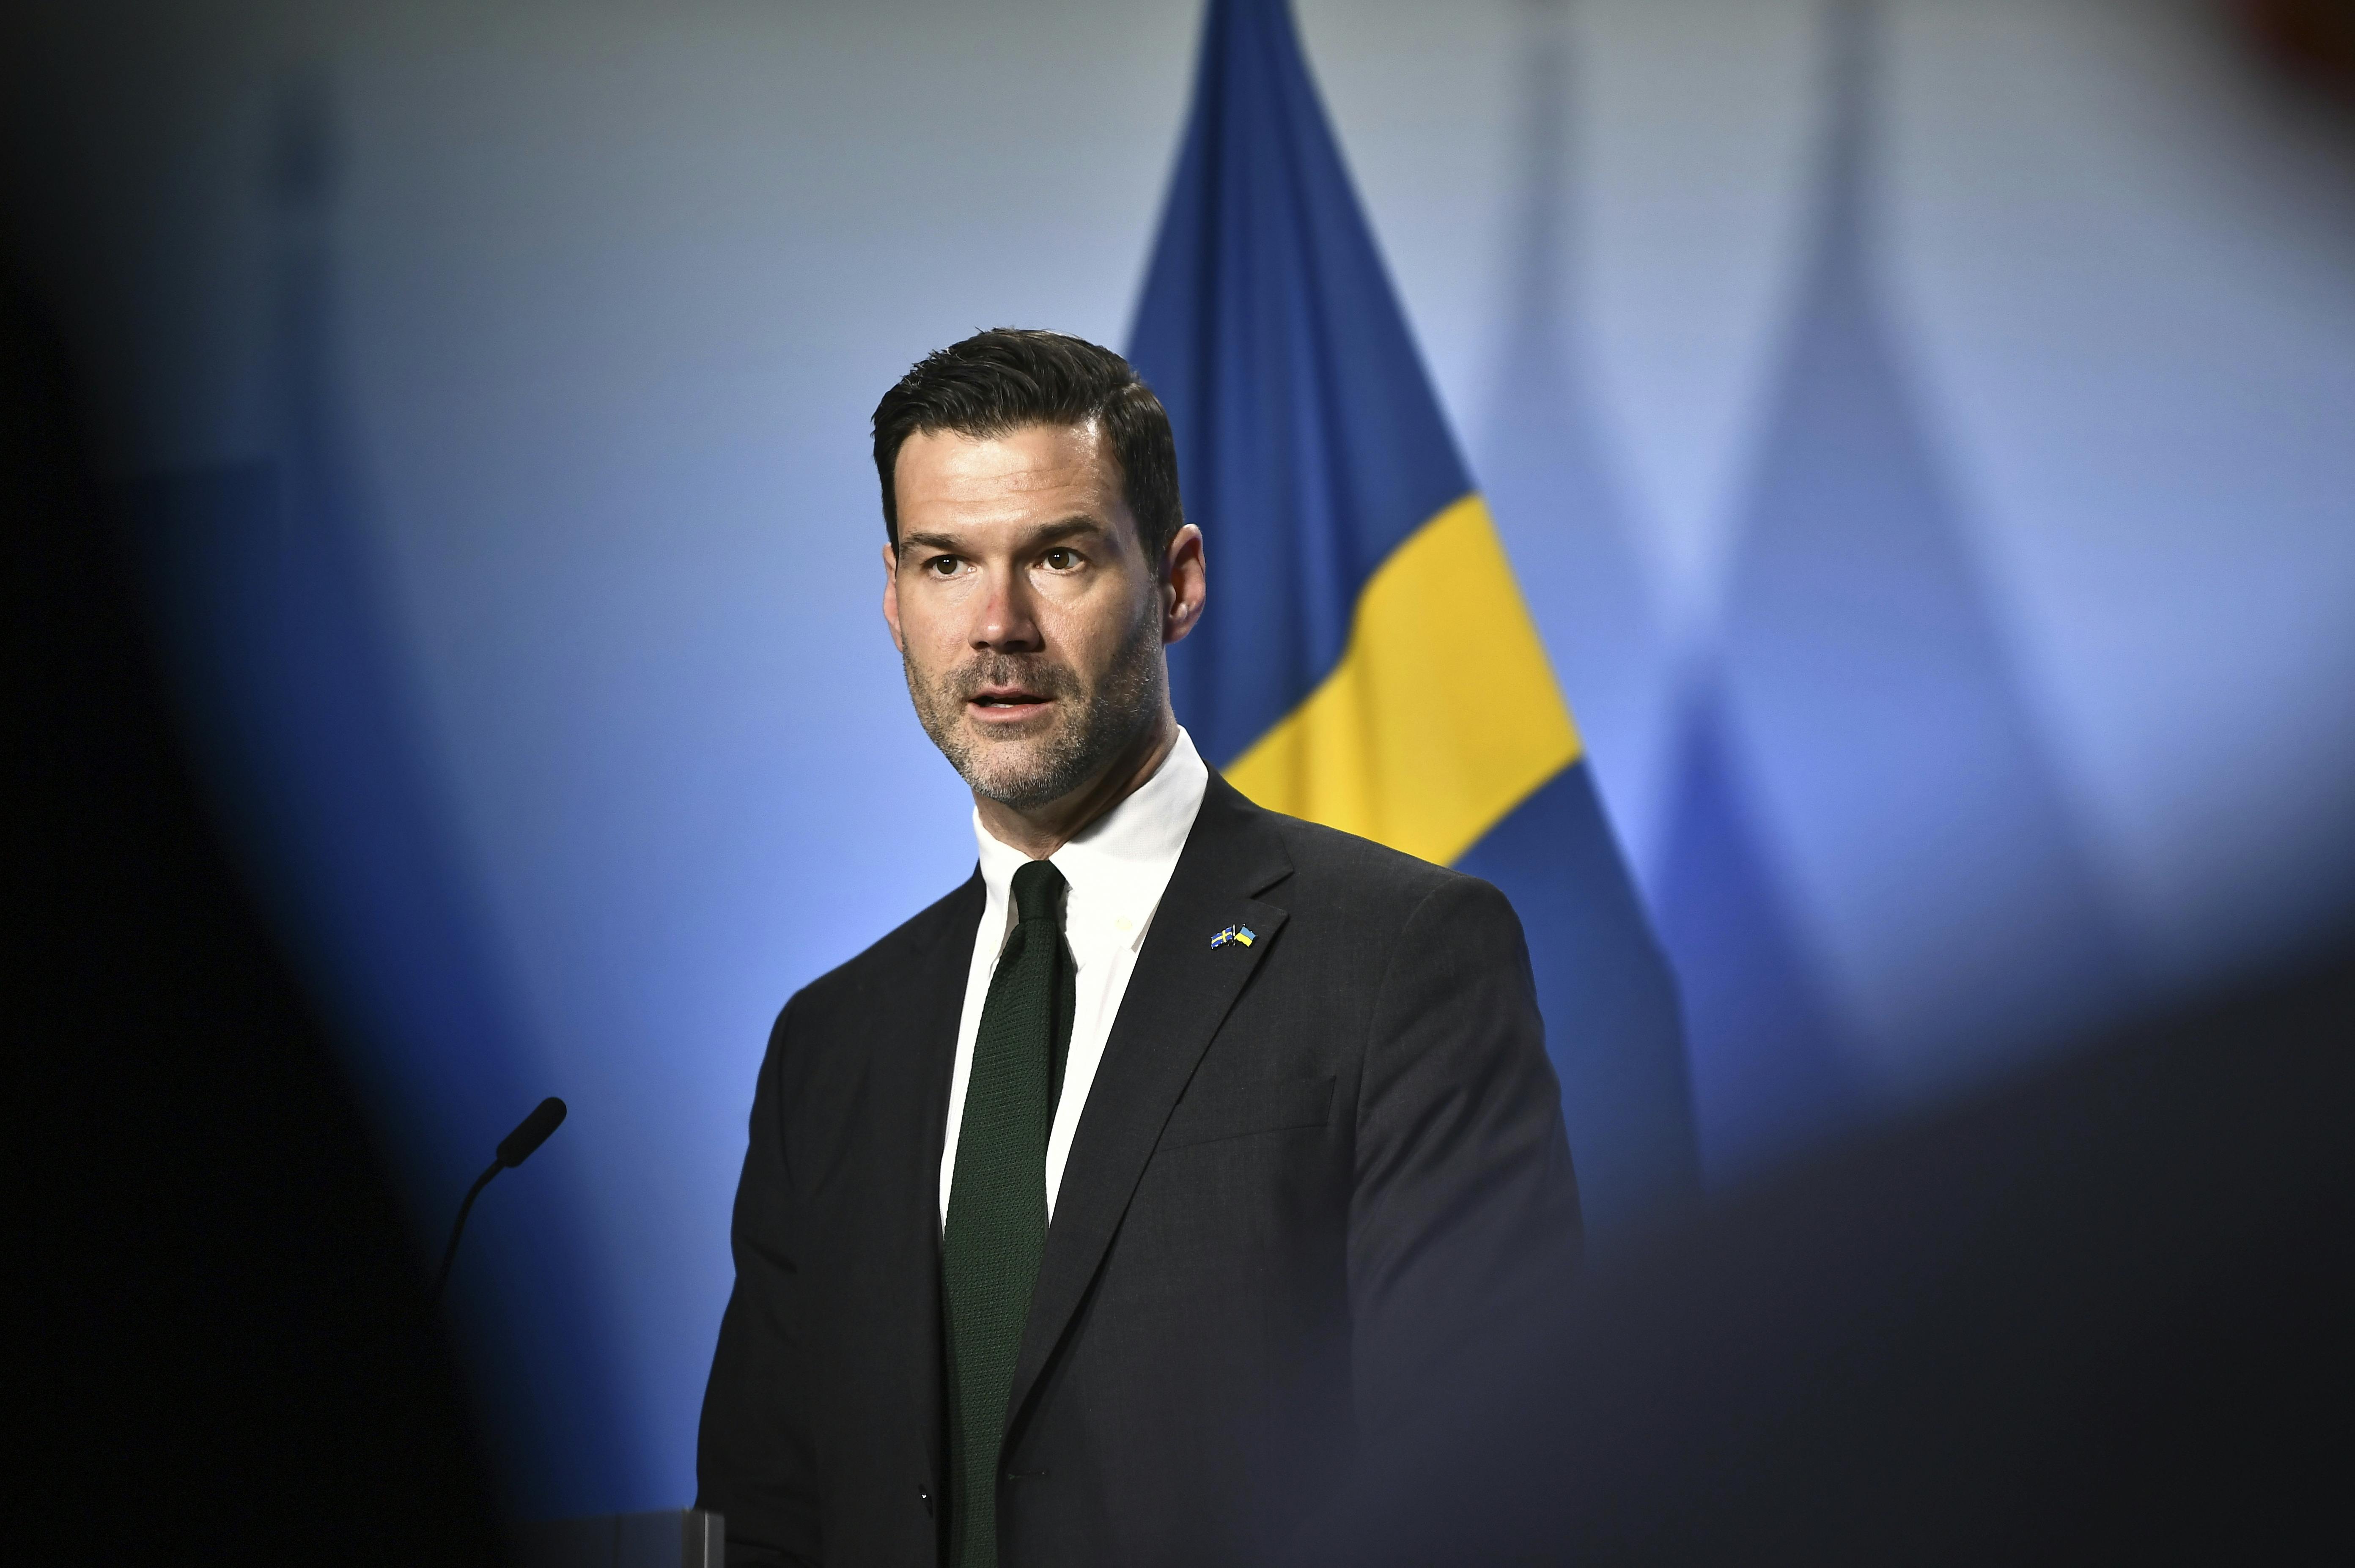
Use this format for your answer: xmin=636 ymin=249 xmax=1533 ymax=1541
xmin=1131 ymin=0 xmax=1696 ymax=1234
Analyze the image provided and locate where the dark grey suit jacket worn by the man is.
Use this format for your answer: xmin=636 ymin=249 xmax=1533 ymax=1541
xmin=697 ymin=775 xmax=1578 ymax=1568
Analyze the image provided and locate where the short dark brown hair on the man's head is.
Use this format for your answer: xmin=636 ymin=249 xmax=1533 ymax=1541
xmin=874 ymin=327 xmax=1185 ymax=572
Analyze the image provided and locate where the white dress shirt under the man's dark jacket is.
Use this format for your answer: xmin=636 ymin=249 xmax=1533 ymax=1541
xmin=940 ymin=730 xmax=1210 ymax=1224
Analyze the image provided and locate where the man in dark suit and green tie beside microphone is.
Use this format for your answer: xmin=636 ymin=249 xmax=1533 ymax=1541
xmin=700 ymin=329 xmax=1578 ymax=1568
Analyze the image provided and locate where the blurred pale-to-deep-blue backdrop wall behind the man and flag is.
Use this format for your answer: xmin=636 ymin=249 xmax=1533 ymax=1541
xmin=9 ymin=0 xmax=2355 ymax=1514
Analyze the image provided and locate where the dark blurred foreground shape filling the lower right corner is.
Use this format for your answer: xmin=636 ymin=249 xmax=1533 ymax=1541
xmin=1331 ymin=932 xmax=2355 ymax=1565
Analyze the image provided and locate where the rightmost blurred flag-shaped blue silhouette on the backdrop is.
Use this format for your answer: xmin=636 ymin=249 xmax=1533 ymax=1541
xmin=1651 ymin=0 xmax=2138 ymax=1187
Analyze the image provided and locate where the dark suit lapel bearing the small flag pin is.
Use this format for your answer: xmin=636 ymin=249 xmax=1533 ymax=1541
xmin=998 ymin=772 xmax=1293 ymax=1431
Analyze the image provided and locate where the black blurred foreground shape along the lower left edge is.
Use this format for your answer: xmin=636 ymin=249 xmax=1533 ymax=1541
xmin=0 ymin=283 xmax=502 ymax=1568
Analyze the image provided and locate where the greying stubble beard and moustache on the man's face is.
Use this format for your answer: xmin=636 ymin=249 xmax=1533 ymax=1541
xmin=900 ymin=596 xmax=1166 ymax=810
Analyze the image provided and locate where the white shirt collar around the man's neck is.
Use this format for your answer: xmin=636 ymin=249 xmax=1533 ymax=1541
xmin=973 ymin=727 xmax=1210 ymax=963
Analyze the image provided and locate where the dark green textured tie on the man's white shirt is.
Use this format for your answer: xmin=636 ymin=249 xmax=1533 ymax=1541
xmin=940 ymin=859 xmax=1071 ymax=1568
